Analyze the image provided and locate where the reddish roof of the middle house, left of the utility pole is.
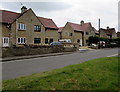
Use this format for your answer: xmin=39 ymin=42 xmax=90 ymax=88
xmin=68 ymin=22 xmax=91 ymax=32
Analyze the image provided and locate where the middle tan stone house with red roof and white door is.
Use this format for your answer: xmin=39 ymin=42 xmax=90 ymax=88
xmin=59 ymin=21 xmax=95 ymax=46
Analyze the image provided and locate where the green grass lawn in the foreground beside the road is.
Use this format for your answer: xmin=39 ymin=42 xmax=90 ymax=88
xmin=3 ymin=57 xmax=120 ymax=90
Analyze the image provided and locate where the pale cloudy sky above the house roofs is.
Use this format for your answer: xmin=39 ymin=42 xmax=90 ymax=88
xmin=0 ymin=0 xmax=119 ymax=31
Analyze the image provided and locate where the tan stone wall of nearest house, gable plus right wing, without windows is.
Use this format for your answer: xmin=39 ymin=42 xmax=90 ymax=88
xmin=11 ymin=10 xmax=58 ymax=45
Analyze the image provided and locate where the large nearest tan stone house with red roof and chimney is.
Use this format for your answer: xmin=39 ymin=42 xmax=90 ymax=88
xmin=0 ymin=6 xmax=59 ymax=47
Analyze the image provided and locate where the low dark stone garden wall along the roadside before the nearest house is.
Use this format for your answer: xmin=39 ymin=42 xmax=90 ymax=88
xmin=2 ymin=46 xmax=77 ymax=58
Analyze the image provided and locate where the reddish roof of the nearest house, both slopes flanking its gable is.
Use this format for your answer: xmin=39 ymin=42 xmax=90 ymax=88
xmin=0 ymin=10 xmax=58 ymax=29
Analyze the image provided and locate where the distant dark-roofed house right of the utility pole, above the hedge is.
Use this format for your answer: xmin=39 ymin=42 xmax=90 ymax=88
xmin=100 ymin=27 xmax=117 ymax=39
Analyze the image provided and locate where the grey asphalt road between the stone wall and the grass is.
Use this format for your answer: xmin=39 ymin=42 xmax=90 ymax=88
xmin=2 ymin=48 xmax=118 ymax=80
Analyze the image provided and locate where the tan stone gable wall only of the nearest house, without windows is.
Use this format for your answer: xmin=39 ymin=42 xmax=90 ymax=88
xmin=12 ymin=10 xmax=45 ymax=45
